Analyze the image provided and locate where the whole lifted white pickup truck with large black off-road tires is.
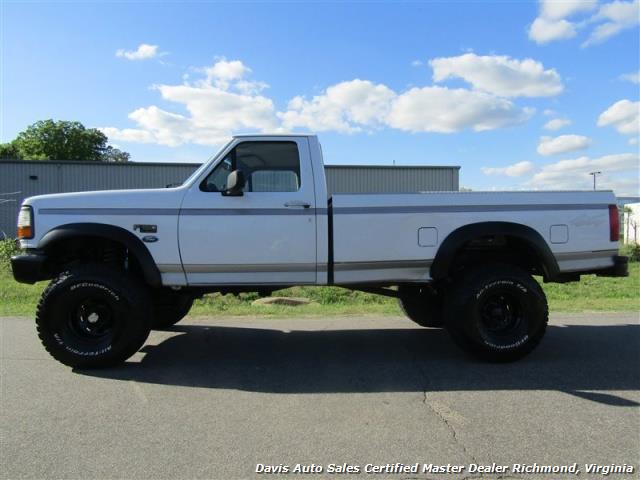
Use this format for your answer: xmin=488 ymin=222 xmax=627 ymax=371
xmin=12 ymin=135 xmax=627 ymax=368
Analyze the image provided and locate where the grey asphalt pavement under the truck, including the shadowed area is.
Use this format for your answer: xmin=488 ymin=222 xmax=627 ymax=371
xmin=0 ymin=313 xmax=640 ymax=479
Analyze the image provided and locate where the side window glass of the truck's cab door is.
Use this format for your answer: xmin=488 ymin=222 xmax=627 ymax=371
xmin=200 ymin=142 xmax=300 ymax=192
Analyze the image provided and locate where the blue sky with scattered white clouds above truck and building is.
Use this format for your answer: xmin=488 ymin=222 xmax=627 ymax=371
xmin=0 ymin=0 xmax=640 ymax=194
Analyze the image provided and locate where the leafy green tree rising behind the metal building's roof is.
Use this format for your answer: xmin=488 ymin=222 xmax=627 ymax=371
xmin=0 ymin=120 xmax=129 ymax=162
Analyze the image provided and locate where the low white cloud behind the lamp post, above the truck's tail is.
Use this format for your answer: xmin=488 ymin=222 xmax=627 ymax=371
xmin=528 ymin=153 xmax=640 ymax=195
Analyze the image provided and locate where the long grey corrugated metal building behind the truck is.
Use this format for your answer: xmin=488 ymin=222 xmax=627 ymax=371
xmin=0 ymin=160 xmax=460 ymax=237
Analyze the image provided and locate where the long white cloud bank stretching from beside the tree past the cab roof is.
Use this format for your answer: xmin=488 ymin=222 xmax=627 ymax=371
xmin=102 ymin=58 xmax=534 ymax=146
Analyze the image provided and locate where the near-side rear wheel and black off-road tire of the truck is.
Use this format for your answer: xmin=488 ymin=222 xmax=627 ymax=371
xmin=444 ymin=265 xmax=549 ymax=362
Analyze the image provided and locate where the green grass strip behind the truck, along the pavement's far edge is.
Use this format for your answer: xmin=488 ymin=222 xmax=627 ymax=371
xmin=0 ymin=262 xmax=640 ymax=317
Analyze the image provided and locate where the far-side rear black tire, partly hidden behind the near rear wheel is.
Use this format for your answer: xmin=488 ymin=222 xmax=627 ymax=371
xmin=398 ymin=285 xmax=444 ymax=328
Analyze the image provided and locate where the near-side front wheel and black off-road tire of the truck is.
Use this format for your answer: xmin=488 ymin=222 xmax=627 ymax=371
xmin=36 ymin=264 xmax=152 ymax=369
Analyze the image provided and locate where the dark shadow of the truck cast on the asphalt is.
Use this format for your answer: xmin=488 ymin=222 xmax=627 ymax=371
xmin=78 ymin=325 xmax=640 ymax=406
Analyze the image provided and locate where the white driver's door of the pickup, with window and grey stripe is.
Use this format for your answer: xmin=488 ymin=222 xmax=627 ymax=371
xmin=179 ymin=137 xmax=316 ymax=285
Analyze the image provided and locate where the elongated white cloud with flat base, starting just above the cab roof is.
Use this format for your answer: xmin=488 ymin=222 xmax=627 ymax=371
xmin=278 ymin=80 xmax=533 ymax=133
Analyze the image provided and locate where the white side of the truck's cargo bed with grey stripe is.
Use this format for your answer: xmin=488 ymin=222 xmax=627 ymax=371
xmin=331 ymin=191 xmax=617 ymax=284
